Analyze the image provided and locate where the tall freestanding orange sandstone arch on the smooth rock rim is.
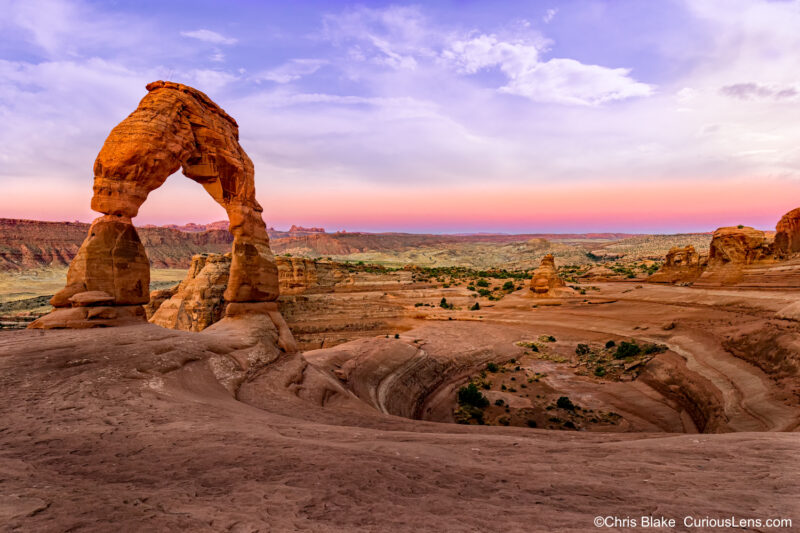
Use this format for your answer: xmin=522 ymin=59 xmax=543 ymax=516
xmin=32 ymin=81 xmax=278 ymax=327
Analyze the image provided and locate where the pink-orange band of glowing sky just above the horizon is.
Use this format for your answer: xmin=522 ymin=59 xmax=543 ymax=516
xmin=3 ymin=174 xmax=800 ymax=233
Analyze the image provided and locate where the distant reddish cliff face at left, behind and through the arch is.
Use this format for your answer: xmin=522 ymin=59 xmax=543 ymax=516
xmin=0 ymin=218 xmax=233 ymax=271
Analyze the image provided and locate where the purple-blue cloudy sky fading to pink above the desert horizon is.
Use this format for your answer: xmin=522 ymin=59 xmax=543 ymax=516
xmin=0 ymin=0 xmax=800 ymax=233
